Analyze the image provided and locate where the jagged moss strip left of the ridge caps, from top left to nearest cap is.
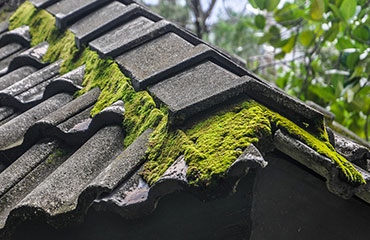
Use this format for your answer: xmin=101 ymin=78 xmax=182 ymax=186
xmin=10 ymin=1 xmax=163 ymax=146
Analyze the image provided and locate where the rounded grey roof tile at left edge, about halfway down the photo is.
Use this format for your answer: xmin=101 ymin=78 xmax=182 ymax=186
xmin=0 ymin=93 xmax=72 ymax=149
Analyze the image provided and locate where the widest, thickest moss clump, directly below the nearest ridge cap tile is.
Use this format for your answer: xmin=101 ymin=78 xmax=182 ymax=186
xmin=143 ymin=101 xmax=271 ymax=187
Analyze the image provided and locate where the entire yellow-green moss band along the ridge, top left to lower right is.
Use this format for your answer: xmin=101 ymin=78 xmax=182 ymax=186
xmin=10 ymin=2 xmax=364 ymax=190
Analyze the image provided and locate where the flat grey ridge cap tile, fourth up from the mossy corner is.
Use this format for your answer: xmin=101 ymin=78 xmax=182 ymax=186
xmin=70 ymin=1 xmax=127 ymax=48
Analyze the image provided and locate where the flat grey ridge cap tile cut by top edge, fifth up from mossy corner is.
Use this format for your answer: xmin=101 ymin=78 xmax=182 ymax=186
xmin=47 ymin=0 xmax=112 ymax=29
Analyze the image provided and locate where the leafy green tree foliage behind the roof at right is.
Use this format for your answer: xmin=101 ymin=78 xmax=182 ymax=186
xmin=249 ymin=0 xmax=370 ymax=140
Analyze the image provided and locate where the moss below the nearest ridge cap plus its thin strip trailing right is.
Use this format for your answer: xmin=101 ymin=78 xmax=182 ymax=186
xmin=142 ymin=100 xmax=365 ymax=187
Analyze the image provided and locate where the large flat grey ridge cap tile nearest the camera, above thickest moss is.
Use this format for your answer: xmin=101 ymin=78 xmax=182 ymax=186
xmin=149 ymin=61 xmax=246 ymax=124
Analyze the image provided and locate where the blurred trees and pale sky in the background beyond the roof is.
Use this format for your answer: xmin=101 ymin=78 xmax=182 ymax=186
xmin=0 ymin=0 xmax=370 ymax=143
